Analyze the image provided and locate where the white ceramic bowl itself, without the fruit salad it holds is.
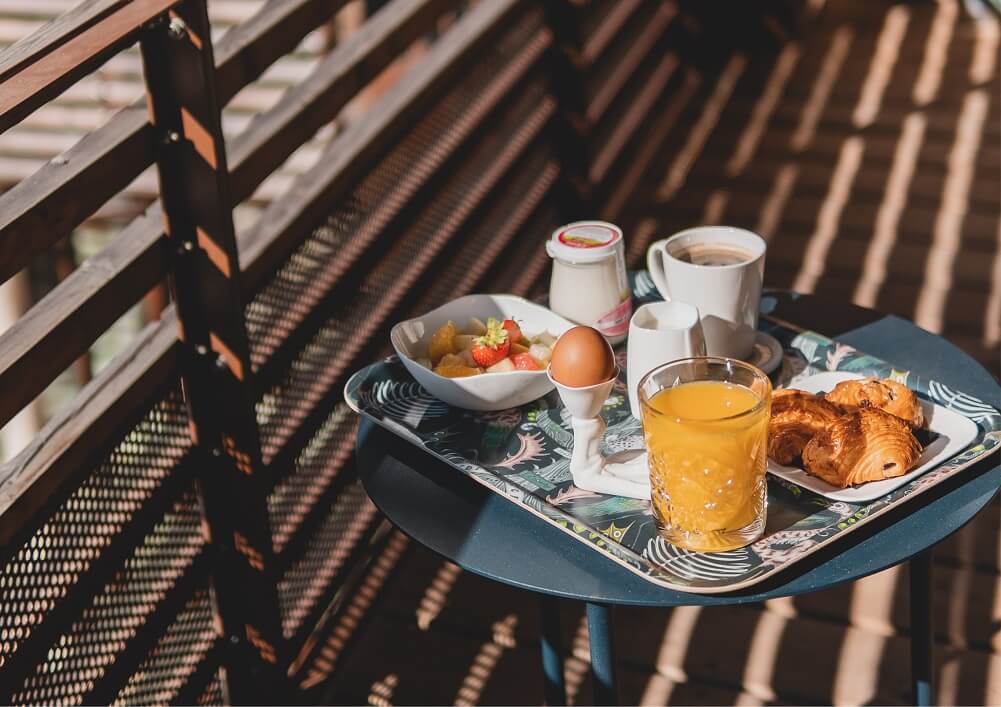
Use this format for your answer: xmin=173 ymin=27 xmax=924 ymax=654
xmin=389 ymin=294 xmax=575 ymax=410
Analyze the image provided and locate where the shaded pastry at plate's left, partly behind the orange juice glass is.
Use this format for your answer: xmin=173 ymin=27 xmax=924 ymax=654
xmin=768 ymin=389 xmax=842 ymax=465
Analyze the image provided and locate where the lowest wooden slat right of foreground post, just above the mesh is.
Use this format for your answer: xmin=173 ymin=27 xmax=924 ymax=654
xmin=240 ymin=0 xmax=521 ymax=292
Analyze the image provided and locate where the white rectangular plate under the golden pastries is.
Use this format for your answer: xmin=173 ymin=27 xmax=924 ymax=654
xmin=768 ymin=371 xmax=977 ymax=504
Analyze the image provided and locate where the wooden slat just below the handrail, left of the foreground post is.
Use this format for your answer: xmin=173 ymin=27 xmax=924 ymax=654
xmin=0 ymin=102 xmax=154 ymax=284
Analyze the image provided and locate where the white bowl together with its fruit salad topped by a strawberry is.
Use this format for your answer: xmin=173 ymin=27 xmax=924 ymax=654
xmin=390 ymin=294 xmax=574 ymax=411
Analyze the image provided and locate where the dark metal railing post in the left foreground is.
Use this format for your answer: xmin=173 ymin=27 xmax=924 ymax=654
xmin=140 ymin=0 xmax=288 ymax=704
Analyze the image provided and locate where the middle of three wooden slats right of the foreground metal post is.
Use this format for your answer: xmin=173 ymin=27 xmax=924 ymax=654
xmin=230 ymin=0 xmax=451 ymax=201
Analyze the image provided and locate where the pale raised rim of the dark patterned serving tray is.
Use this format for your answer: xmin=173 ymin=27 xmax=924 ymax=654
xmin=343 ymin=330 xmax=1001 ymax=595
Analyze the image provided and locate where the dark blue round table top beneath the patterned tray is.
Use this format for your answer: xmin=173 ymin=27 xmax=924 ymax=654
xmin=357 ymin=292 xmax=1001 ymax=607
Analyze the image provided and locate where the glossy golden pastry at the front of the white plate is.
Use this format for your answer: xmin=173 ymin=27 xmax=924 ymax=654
xmin=803 ymin=408 xmax=921 ymax=489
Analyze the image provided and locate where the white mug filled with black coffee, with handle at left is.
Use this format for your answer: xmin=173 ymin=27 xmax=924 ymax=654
xmin=647 ymin=226 xmax=766 ymax=359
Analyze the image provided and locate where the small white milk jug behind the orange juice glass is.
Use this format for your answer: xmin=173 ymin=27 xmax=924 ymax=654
xmin=626 ymin=301 xmax=706 ymax=420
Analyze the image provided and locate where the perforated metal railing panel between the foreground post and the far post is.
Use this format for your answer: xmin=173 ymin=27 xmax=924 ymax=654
xmin=246 ymin=2 xmax=559 ymax=656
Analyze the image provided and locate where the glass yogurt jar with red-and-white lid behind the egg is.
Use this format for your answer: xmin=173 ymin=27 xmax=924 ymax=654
xmin=546 ymin=221 xmax=633 ymax=343
